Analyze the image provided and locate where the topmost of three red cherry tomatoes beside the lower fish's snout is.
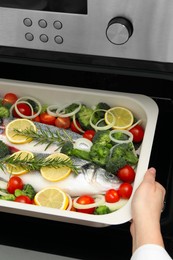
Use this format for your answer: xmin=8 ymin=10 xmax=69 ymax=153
xmin=117 ymin=165 xmax=136 ymax=183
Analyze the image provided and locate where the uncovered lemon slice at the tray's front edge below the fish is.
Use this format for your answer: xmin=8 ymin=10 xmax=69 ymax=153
xmin=34 ymin=187 xmax=69 ymax=210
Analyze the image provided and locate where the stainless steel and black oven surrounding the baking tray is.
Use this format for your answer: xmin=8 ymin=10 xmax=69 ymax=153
xmin=0 ymin=0 xmax=173 ymax=260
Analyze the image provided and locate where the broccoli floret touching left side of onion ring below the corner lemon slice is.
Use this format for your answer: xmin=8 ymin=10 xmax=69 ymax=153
xmin=92 ymin=130 xmax=112 ymax=148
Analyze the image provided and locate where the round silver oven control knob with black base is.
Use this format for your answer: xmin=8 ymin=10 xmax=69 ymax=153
xmin=106 ymin=17 xmax=133 ymax=45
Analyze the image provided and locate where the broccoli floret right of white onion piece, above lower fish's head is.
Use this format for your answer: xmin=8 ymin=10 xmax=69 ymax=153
xmin=89 ymin=143 xmax=110 ymax=167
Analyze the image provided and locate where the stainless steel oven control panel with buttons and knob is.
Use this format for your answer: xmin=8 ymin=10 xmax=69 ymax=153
xmin=0 ymin=0 xmax=173 ymax=62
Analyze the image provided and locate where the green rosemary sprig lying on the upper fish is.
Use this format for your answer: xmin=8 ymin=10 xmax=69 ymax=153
xmin=13 ymin=126 xmax=73 ymax=150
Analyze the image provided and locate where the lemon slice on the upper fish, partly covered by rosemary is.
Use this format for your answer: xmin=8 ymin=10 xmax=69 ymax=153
xmin=5 ymin=118 xmax=37 ymax=144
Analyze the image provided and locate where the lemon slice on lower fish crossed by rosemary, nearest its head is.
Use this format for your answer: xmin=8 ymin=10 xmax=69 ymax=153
xmin=40 ymin=153 xmax=71 ymax=182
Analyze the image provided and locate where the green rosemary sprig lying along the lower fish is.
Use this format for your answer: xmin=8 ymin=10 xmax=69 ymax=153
xmin=0 ymin=153 xmax=78 ymax=173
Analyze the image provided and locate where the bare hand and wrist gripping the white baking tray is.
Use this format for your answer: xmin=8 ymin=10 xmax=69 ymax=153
xmin=130 ymin=168 xmax=165 ymax=252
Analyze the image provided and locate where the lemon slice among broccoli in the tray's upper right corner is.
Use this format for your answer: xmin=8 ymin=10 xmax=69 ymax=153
xmin=105 ymin=107 xmax=134 ymax=129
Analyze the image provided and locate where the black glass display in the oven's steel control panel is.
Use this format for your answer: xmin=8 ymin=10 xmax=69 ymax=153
xmin=0 ymin=0 xmax=87 ymax=14
